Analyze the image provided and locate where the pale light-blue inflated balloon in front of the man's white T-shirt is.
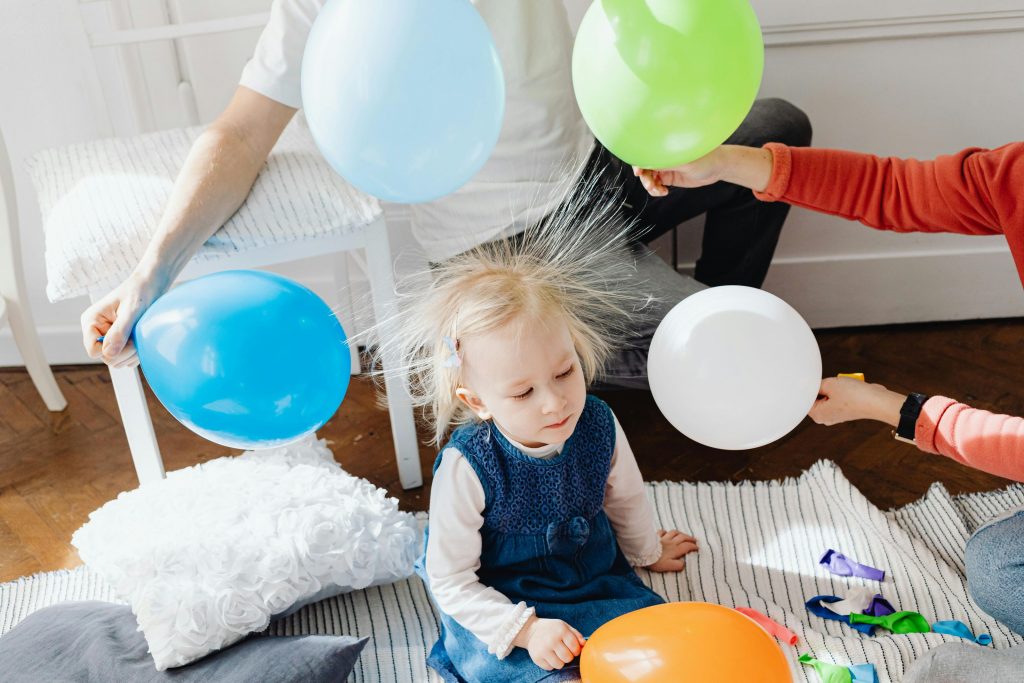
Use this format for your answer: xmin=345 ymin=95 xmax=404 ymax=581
xmin=302 ymin=0 xmax=503 ymax=203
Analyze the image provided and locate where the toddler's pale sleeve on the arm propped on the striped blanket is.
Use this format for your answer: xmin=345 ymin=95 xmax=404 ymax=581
xmin=604 ymin=419 xmax=662 ymax=566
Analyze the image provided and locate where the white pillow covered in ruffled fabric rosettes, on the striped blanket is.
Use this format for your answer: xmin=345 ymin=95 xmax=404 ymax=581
xmin=72 ymin=437 xmax=419 ymax=671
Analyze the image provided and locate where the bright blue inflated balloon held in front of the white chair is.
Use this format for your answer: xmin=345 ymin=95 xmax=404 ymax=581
xmin=133 ymin=270 xmax=350 ymax=449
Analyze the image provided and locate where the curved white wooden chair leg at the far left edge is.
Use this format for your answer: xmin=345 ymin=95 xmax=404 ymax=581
xmin=0 ymin=133 xmax=68 ymax=413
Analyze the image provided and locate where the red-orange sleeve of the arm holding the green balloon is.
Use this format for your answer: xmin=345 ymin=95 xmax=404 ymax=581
xmin=756 ymin=142 xmax=1024 ymax=237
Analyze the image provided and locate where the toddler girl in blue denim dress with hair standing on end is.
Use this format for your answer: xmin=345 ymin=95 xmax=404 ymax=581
xmin=384 ymin=200 xmax=696 ymax=683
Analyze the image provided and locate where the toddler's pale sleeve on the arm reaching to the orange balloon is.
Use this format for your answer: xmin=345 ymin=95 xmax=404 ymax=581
xmin=426 ymin=447 xmax=534 ymax=659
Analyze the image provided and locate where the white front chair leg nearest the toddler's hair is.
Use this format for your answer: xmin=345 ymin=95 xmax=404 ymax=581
xmin=367 ymin=219 xmax=423 ymax=488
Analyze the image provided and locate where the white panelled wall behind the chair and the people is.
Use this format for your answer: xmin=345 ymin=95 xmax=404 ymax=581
xmin=0 ymin=0 xmax=1024 ymax=366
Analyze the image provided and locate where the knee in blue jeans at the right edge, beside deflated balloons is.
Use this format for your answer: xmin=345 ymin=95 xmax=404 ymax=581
xmin=965 ymin=515 xmax=1024 ymax=635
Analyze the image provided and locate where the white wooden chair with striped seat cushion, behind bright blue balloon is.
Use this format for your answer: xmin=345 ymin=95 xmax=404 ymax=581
xmin=30 ymin=0 xmax=423 ymax=488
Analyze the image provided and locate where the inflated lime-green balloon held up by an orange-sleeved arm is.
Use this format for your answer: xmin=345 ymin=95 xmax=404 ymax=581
xmin=572 ymin=0 xmax=764 ymax=168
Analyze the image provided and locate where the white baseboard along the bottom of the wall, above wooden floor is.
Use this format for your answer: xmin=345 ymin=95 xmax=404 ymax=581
xmin=0 ymin=249 xmax=1024 ymax=367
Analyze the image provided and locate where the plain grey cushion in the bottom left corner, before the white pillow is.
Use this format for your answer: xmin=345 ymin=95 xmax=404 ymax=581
xmin=0 ymin=601 xmax=368 ymax=683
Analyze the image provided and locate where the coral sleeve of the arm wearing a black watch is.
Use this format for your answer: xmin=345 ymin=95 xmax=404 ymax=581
xmin=914 ymin=396 xmax=1024 ymax=481
